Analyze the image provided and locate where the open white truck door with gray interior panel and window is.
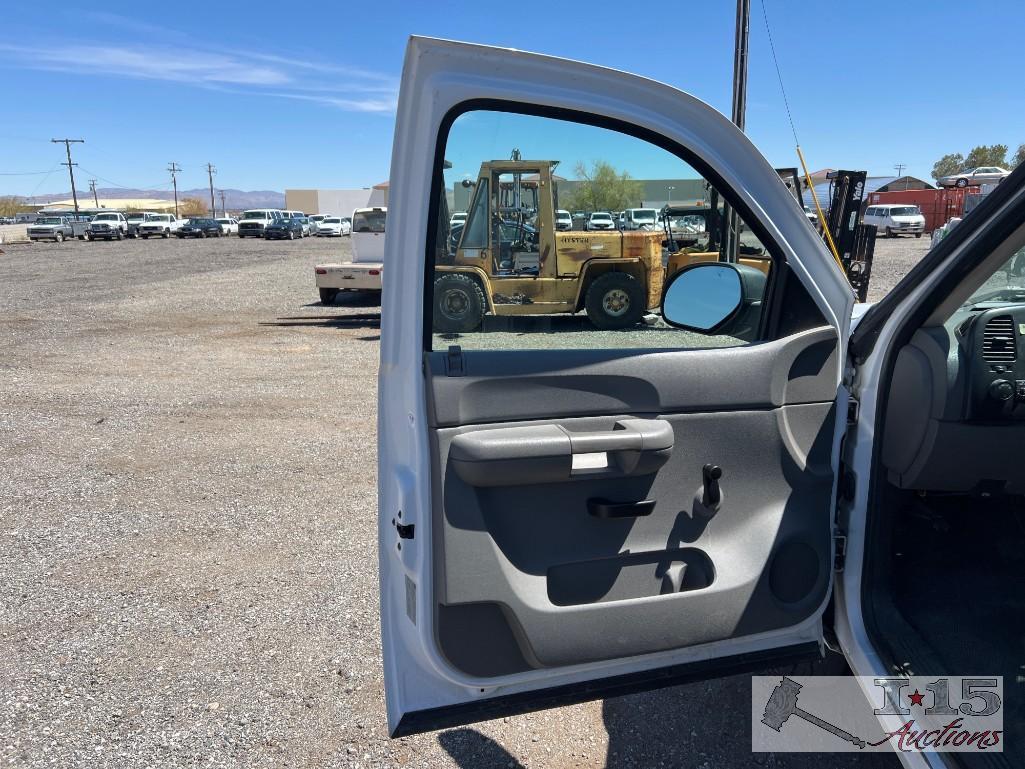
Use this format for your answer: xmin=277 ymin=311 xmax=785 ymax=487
xmin=378 ymin=38 xmax=853 ymax=735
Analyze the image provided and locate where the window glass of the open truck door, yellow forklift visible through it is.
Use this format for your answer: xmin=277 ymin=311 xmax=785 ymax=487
xmin=428 ymin=111 xmax=772 ymax=350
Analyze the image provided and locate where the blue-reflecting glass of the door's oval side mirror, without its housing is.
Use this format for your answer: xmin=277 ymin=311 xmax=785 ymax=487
xmin=662 ymin=264 xmax=741 ymax=331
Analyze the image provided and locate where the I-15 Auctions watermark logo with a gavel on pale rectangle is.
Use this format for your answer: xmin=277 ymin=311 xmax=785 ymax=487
xmin=751 ymin=676 xmax=1003 ymax=753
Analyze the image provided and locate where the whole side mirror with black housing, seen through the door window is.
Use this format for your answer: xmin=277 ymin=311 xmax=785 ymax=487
xmin=662 ymin=261 xmax=766 ymax=336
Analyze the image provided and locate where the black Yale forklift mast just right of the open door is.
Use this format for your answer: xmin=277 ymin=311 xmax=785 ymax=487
xmin=826 ymin=171 xmax=875 ymax=301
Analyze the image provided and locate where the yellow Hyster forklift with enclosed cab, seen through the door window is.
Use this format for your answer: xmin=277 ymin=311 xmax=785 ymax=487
xmin=434 ymin=159 xmax=664 ymax=333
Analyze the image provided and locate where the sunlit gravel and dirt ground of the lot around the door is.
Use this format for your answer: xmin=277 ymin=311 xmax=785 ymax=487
xmin=0 ymin=239 xmax=927 ymax=767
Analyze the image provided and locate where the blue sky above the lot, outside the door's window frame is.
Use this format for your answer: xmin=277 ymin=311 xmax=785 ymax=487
xmin=0 ymin=0 xmax=1025 ymax=195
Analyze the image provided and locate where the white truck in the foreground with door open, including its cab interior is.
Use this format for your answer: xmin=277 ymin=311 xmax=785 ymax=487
xmin=377 ymin=37 xmax=1025 ymax=769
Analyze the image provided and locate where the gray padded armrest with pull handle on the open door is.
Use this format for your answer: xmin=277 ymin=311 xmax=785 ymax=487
xmin=448 ymin=419 xmax=673 ymax=486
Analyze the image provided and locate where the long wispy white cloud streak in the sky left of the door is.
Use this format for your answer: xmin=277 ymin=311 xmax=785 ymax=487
xmin=0 ymin=42 xmax=398 ymax=113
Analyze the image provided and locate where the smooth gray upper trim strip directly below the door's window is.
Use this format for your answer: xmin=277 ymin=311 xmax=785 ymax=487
xmin=425 ymin=326 xmax=839 ymax=428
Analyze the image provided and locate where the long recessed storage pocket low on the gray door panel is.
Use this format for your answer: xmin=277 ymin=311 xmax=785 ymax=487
xmin=547 ymin=548 xmax=715 ymax=606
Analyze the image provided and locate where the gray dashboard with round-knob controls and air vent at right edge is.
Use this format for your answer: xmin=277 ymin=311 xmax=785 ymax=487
xmin=882 ymin=297 xmax=1025 ymax=494
